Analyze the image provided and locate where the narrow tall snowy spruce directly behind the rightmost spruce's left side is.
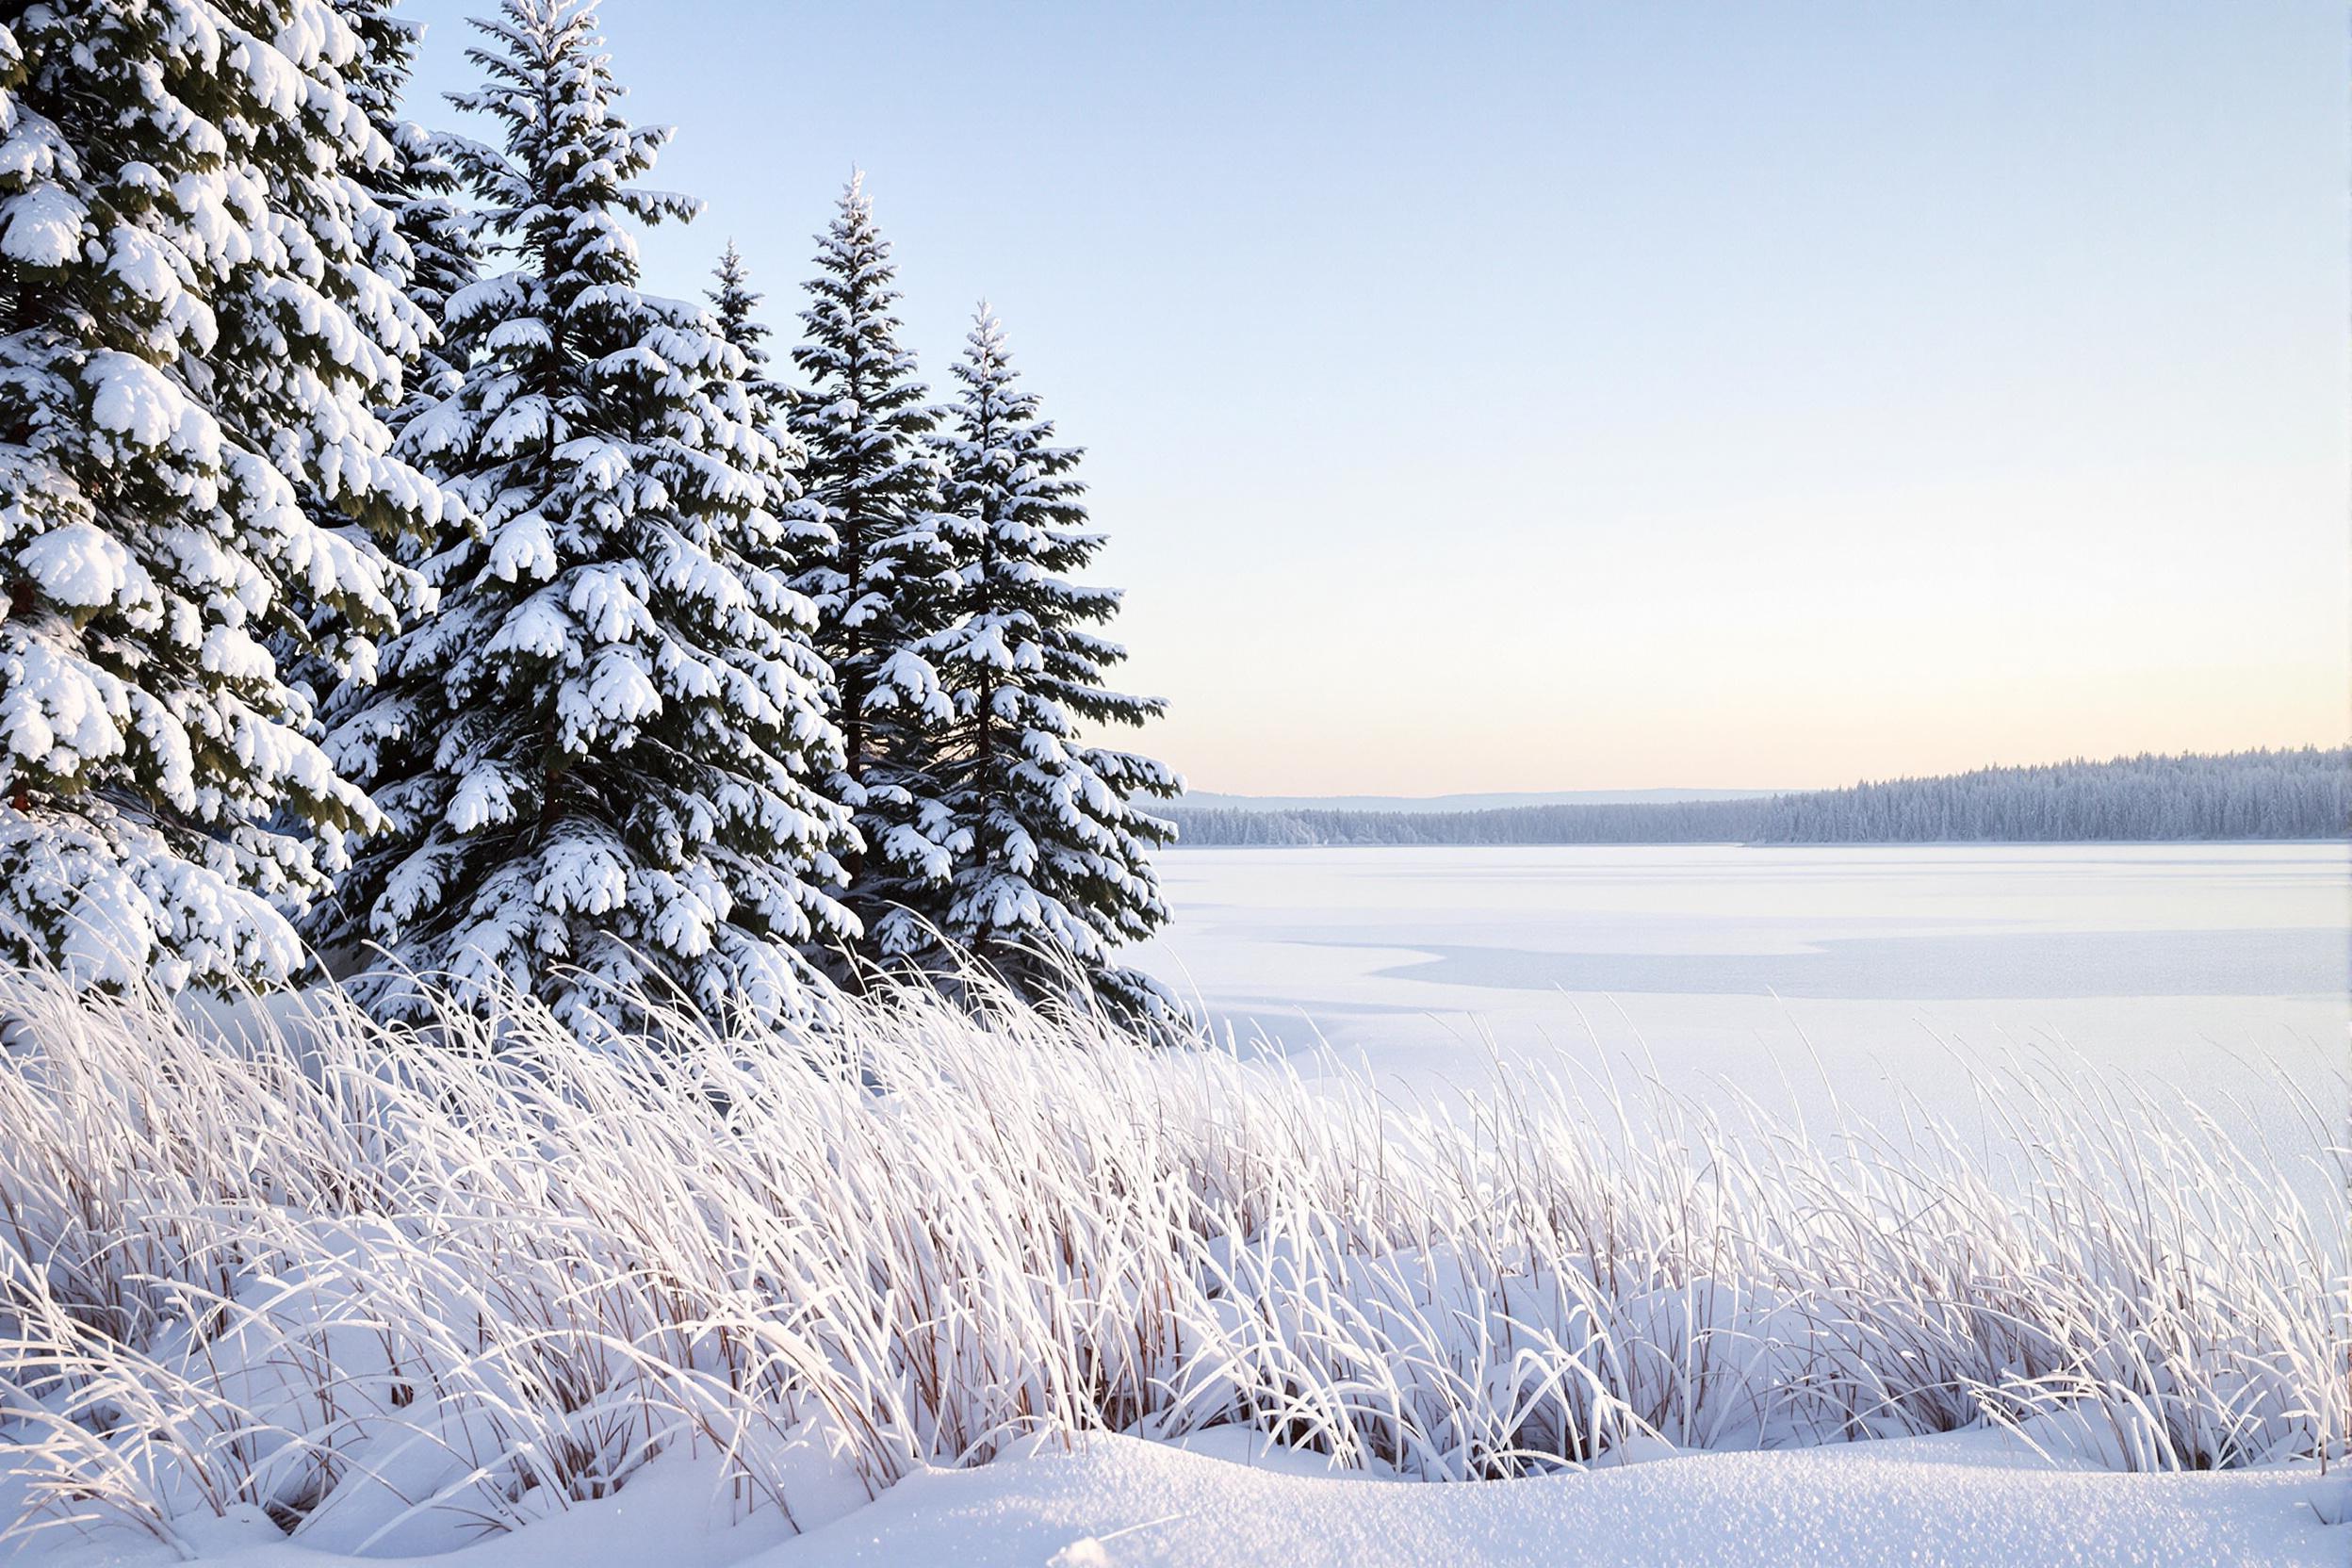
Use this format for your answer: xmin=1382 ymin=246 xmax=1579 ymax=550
xmin=791 ymin=176 xmax=953 ymax=966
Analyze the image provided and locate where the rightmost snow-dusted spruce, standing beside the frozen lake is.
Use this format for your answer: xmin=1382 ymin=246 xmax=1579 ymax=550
xmin=924 ymin=305 xmax=1183 ymax=1022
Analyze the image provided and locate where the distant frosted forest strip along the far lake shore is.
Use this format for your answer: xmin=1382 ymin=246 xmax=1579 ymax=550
xmin=1162 ymin=747 xmax=2352 ymax=846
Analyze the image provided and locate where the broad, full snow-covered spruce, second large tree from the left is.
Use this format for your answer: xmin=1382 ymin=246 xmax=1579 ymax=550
xmin=332 ymin=0 xmax=849 ymax=1032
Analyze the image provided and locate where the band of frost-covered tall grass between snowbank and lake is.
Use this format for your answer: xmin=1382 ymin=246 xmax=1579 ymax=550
xmin=0 ymin=971 xmax=2347 ymax=1552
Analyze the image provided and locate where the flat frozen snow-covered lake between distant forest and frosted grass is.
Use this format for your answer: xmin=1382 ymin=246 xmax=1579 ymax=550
xmin=1136 ymin=844 xmax=2352 ymax=1142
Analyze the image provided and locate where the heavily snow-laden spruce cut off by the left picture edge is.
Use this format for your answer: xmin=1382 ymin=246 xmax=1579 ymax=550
xmin=0 ymin=0 xmax=440 ymax=985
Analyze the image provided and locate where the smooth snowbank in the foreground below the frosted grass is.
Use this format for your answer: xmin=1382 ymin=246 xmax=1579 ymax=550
xmin=13 ymin=1431 xmax=2352 ymax=1568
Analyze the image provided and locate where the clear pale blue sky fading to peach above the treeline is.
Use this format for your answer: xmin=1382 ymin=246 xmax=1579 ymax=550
xmin=412 ymin=0 xmax=2352 ymax=794
